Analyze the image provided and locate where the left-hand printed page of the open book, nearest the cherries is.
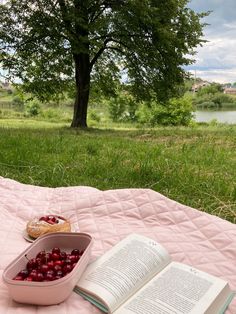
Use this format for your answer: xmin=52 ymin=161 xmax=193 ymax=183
xmin=76 ymin=234 xmax=170 ymax=311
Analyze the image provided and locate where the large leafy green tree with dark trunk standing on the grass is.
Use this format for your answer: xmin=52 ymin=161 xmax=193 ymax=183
xmin=0 ymin=0 xmax=207 ymax=127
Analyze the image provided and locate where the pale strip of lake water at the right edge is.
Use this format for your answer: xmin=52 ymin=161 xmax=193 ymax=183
xmin=194 ymin=110 xmax=236 ymax=124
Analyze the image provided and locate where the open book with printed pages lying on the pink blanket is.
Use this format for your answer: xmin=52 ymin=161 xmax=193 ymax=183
xmin=75 ymin=234 xmax=234 ymax=314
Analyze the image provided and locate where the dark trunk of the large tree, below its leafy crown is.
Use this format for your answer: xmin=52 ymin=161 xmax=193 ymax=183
xmin=71 ymin=53 xmax=90 ymax=128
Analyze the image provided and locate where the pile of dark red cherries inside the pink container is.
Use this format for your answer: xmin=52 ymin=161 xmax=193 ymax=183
xmin=13 ymin=247 xmax=83 ymax=281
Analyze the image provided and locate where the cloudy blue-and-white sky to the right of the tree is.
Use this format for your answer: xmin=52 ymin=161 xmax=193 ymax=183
xmin=187 ymin=0 xmax=236 ymax=83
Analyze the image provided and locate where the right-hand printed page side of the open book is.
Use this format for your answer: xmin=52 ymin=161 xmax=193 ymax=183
xmin=114 ymin=262 xmax=230 ymax=314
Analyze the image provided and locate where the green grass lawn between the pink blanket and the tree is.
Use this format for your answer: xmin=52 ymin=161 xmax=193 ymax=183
xmin=0 ymin=119 xmax=236 ymax=223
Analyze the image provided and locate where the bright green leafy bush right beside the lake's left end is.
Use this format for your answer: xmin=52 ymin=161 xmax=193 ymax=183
xmin=138 ymin=97 xmax=193 ymax=126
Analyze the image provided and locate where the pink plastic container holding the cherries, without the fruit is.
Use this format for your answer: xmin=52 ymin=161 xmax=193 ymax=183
xmin=2 ymin=232 xmax=92 ymax=305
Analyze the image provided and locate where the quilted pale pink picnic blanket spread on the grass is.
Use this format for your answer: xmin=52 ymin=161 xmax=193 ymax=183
xmin=0 ymin=177 xmax=236 ymax=314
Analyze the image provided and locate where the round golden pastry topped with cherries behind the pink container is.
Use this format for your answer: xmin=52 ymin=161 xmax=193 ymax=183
xmin=26 ymin=215 xmax=71 ymax=239
